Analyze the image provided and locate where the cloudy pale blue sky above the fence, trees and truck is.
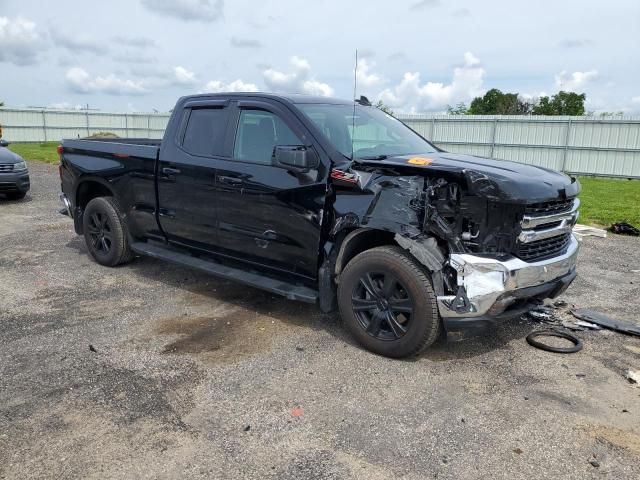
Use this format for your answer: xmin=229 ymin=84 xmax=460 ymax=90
xmin=0 ymin=0 xmax=640 ymax=114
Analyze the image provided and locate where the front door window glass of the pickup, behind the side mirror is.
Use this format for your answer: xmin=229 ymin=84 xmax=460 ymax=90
xmin=233 ymin=110 xmax=304 ymax=165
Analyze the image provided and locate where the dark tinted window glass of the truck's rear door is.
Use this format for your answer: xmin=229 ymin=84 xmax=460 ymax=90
xmin=182 ymin=108 xmax=228 ymax=156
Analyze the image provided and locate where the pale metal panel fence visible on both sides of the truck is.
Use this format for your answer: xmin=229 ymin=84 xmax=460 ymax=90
xmin=0 ymin=108 xmax=640 ymax=178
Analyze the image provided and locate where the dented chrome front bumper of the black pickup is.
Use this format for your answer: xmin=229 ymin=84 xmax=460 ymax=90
xmin=437 ymin=235 xmax=579 ymax=318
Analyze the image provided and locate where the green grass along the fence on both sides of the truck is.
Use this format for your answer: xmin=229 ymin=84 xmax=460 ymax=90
xmin=10 ymin=142 xmax=640 ymax=227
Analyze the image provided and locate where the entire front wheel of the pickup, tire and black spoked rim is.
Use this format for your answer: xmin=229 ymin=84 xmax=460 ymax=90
xmin=338 ymin=246 xmax=440 ymax=358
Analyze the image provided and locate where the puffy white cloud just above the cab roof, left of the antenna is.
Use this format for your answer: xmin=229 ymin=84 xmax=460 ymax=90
xmin=262 ymin=56 xmax=333 ymax=97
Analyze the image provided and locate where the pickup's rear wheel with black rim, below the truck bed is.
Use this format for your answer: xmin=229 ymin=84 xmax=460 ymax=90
xmin=82 ymin=197 xmax=133 ymax=267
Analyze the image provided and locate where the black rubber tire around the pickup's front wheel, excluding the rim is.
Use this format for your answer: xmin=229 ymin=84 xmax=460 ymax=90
xmin=338 ymin=249 xmax=440 ymax=358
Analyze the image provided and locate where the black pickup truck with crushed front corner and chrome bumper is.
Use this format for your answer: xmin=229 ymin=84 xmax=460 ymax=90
xmin=59 ymin=93 xmax=580 ymax=357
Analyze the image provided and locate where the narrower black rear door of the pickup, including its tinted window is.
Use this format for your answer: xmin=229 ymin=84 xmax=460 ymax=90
xmin=158 ymin=100 xmax=232 ymax=250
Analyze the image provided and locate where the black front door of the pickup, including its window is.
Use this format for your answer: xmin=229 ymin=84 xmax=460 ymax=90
xmin=216 ymin=100 xmax=327 ymax=278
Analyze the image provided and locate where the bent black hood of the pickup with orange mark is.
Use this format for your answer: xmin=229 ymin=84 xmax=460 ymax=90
xmin=352 ymin=152 xmax=580 ymax=203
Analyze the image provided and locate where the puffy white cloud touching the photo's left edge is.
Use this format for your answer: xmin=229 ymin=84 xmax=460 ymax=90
xmin=0 ymin=17 xmax=44 ymax=65
